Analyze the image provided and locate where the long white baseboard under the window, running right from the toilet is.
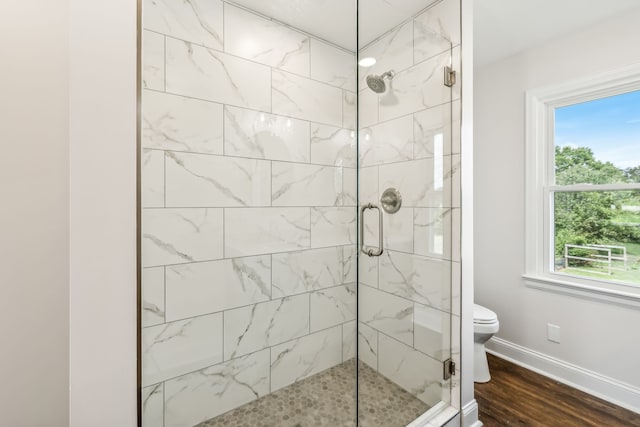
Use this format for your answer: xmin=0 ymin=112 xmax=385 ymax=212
xmin=486 ymin=337 xmax=640 ymax=413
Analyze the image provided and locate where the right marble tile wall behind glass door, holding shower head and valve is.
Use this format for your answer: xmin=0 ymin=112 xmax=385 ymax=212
xmin=358 ymin=0 xmax=461 ymax=412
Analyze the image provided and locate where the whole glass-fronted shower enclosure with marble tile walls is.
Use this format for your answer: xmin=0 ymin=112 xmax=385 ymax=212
xmin=140 ymin=0 xmax=461 ymax=427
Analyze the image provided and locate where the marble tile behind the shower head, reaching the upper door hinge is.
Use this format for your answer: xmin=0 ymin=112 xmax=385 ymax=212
xmin=380 ymin=53 xmax=452 ymax=121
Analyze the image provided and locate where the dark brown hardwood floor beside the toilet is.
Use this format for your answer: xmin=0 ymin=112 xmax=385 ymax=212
xmin=475 ymin=355 xmax=640 ymax=427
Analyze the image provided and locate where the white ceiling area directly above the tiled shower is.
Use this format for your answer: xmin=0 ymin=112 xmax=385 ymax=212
xmin=232 ymin=0 xmax=435 ymax=52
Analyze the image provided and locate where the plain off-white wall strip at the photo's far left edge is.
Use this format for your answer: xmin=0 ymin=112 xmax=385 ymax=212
xmin=0 ymin=0 xmax=69 ymax=427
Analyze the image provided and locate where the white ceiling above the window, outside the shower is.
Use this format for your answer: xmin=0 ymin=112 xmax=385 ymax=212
xmin=473 ymin=0 xmax=640 ymax=67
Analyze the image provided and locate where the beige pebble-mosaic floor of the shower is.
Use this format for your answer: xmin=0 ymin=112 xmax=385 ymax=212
xmin=196 ymin=359 xmax=429 ymax=427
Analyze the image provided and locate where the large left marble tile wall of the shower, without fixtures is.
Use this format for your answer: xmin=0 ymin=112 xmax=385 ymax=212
xmin=142 ymin=0 xmax=358 ymax=427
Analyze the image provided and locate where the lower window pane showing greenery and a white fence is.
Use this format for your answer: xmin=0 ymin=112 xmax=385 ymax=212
xmin=554 ymin=191 xmax=640 ymax=285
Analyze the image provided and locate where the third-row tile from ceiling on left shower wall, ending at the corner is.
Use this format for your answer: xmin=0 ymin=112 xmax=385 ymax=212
xmin=311 ymin=123 xmax=357 ymax=168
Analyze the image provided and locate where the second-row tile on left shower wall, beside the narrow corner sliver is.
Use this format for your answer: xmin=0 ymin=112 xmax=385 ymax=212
xmin=272 ymin=70 xmax=342 ymax=126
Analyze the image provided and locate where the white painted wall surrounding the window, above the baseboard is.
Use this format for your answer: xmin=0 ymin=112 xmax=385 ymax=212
xmin=474 ymin=5 xmax=640 ymax=404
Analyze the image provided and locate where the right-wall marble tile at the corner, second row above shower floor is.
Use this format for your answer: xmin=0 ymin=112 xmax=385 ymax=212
xmin=358 ymin=284 xmax=413 ymax=345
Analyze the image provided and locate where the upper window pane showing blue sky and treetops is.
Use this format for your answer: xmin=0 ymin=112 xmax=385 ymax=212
xmin=555 ymin=91 xmax=640 ymax=185
